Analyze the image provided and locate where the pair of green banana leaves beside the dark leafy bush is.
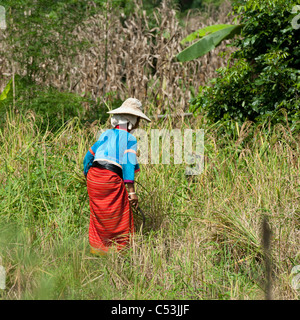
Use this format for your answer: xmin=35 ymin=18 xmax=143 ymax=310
xmin=176 ymin=24 xmax=244 ymax=62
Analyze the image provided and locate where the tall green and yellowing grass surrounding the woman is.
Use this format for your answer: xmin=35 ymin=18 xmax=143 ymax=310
xmin=0 ymin=113 xmax=300 ymax=299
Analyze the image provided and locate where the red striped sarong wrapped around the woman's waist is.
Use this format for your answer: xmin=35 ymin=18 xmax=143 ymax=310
xmin=87 ymin=167 xmax=134 ymax=254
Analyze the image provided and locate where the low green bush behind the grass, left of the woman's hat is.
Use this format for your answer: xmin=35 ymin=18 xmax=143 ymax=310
xmin=0 ymin=76 xmax=108 ymax=131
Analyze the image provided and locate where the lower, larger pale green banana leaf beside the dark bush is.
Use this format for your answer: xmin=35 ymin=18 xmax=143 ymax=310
xmin=176 ymin=24 xmax=243 ymax=62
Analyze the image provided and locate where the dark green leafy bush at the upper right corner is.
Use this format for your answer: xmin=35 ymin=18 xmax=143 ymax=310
xmin=191 ymin=0 xmax=300 ymax=127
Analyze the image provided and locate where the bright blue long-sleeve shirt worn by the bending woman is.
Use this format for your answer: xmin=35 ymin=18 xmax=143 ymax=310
xmin=83 ymin=129 xmax=140 ymax=183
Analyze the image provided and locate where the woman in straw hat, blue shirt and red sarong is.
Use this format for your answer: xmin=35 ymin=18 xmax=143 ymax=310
xmin=83 ymin=98 xmax=151 ymax=254
